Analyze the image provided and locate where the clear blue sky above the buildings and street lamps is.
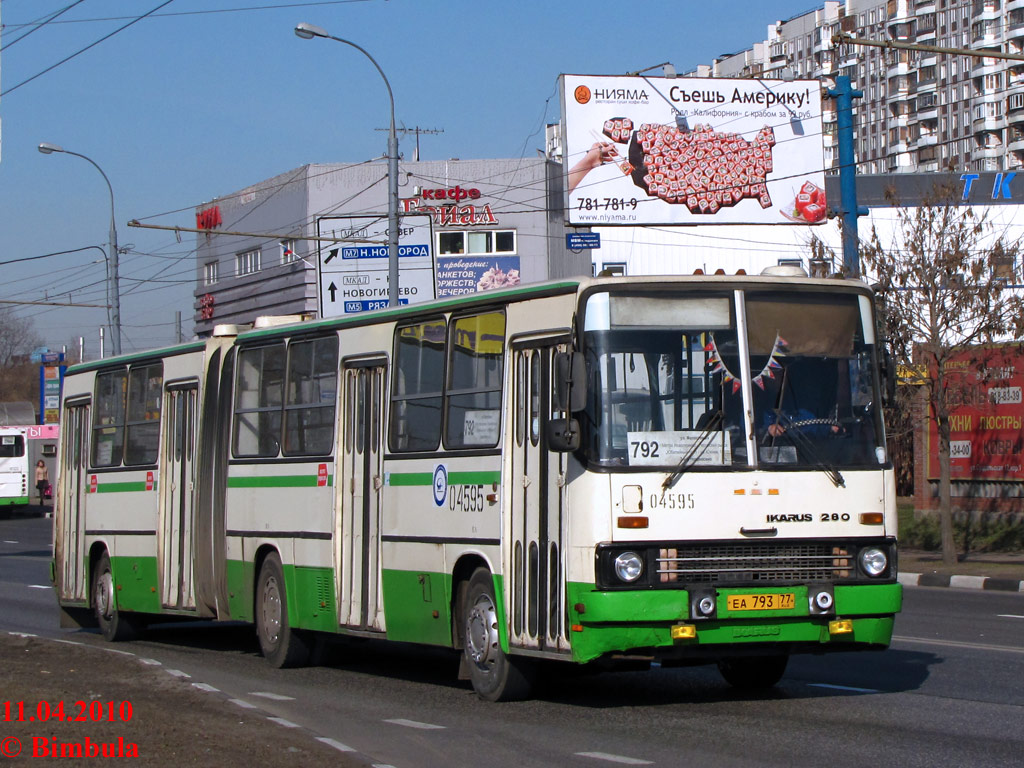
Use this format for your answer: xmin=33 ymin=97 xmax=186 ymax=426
xmin=0 ymin=0 xmax=821 ymax=358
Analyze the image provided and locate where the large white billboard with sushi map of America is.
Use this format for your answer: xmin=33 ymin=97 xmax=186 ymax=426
xmin=561 ymin=75 xmax=828 ymax=225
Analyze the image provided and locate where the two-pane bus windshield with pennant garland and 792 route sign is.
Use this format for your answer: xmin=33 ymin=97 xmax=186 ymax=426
xmin=580 ymin=287 xmax=885 ymax=470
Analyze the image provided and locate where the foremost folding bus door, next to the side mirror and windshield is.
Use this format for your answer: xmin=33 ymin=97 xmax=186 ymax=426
xmin=506 ymin=337 xmax=568 ymax=651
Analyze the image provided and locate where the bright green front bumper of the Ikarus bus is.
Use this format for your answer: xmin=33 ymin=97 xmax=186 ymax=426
xmin=568 ymin=583 xmax=903 ymax=662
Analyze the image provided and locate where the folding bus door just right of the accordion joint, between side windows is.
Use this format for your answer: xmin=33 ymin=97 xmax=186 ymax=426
xmin=335 ymin=358 xmax=386 ymax=632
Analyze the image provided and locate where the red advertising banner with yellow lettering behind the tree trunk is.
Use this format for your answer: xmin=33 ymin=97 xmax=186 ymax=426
xmin=928 ymin=347 xmax=1024 ymax=480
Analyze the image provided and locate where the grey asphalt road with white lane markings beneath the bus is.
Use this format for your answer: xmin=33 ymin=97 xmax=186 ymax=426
xmin=0 ymin=518 xmax=1024 ymax=768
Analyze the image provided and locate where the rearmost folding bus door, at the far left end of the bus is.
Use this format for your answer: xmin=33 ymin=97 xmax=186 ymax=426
xmin=54 ymin=402 xmax=89 ymax=600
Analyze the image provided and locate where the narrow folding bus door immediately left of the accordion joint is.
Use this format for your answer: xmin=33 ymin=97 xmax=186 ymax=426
xmin=160 ymin=385 xmax=199 ymax=608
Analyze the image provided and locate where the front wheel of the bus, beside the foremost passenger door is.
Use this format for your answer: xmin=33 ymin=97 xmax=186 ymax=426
xmin=462 ymin=568 xmax=532 ymax=701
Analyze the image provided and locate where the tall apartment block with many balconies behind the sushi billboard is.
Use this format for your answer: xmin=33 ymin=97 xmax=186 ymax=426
xmin=691 ymin=0 xmax=1024 ymax=174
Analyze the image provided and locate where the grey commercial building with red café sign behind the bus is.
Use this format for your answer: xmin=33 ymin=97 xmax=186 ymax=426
xmin=195 ymin=158 xmax=590 ymax=336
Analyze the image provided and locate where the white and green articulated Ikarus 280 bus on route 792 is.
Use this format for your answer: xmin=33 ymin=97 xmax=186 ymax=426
xmin=53 ymin=275 xmax=902 ymax=700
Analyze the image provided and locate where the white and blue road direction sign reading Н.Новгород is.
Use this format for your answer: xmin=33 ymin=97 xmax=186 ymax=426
xmin=316 ymin=214 xmax=434 ymax=317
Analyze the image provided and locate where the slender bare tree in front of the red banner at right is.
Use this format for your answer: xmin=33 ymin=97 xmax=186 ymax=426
xmin=861 ymin=187 xmax=1024 ymax=565
